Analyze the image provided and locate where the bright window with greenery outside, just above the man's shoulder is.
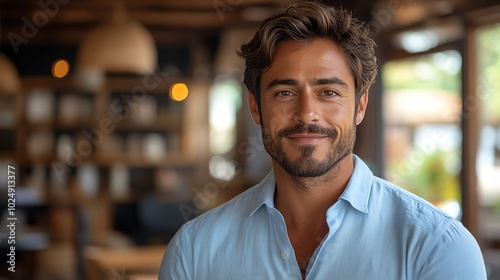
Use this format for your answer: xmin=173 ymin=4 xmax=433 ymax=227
xmin=382 ymin=50 xmax=462 ymax=219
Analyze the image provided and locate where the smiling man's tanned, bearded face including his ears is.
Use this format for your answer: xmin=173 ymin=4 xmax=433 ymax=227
xmin=249 ymin=39 xmax=368 ymax=177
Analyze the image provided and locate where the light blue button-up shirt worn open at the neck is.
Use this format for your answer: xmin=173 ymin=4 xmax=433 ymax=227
xmin=159 ymin=157 xmax=486 ymax=280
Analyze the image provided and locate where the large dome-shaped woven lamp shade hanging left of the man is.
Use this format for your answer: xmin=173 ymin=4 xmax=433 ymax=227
xmin=77 ymin=16 xmax=158 ymax=75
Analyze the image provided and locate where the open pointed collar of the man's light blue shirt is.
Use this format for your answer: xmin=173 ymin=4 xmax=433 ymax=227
xmin=248 ymin=155 xmax=373 ymax=216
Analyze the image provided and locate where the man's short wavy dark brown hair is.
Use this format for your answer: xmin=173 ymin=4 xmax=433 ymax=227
xmin=237 ymin=2 xmax=377 ymax=110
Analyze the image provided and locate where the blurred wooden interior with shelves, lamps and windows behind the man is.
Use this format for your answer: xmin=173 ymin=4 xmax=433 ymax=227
xmin=0 ymin=0 xmax=500 ymax=279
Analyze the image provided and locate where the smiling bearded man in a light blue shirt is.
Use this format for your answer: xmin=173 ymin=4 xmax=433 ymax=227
xmin=159 ymin=2 xmax=486 ymax=280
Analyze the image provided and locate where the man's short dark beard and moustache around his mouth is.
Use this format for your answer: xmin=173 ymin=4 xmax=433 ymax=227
xmin=262 ymin=123 xmax=356 ymax=177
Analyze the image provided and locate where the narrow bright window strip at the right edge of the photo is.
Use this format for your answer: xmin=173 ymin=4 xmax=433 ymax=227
xmin=476 ymin=24 xmax=500 ymax=244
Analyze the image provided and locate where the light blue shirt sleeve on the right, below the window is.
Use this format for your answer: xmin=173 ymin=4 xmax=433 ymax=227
xmin=418 ymin=221 xmax=487 ymax=280
